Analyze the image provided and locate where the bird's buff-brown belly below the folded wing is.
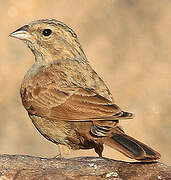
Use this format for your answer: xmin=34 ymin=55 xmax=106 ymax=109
xmin=30 ymin=115 xmax=97 ymax=150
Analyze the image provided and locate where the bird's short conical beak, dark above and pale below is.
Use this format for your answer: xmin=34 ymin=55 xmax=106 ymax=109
xmin=9 ymin=25 xmax=31 ymax=40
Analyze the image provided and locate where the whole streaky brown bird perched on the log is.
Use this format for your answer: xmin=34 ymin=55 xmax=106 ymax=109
xmin=10 ymin=19 xmax=160 ymax=161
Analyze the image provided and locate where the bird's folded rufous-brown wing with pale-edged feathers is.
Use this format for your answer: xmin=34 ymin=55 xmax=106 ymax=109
xmin=21 ymin=63 xmax=132 ymax=121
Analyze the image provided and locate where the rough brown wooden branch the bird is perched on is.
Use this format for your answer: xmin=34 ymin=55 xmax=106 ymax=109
xmin=0 ymin=155 xmax=171 ymax=180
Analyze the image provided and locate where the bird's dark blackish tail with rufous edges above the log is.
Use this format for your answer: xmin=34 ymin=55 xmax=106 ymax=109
xmin=105 ymin=133 xmax=161 ymax=161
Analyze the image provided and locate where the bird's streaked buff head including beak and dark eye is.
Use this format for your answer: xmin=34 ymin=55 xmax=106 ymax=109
xmin=10 ymin=19 xmax=86 ymax=63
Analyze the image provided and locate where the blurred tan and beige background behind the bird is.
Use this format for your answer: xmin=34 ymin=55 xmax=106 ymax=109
xmin=0 ymin=0 xmax=171 ymax=165
